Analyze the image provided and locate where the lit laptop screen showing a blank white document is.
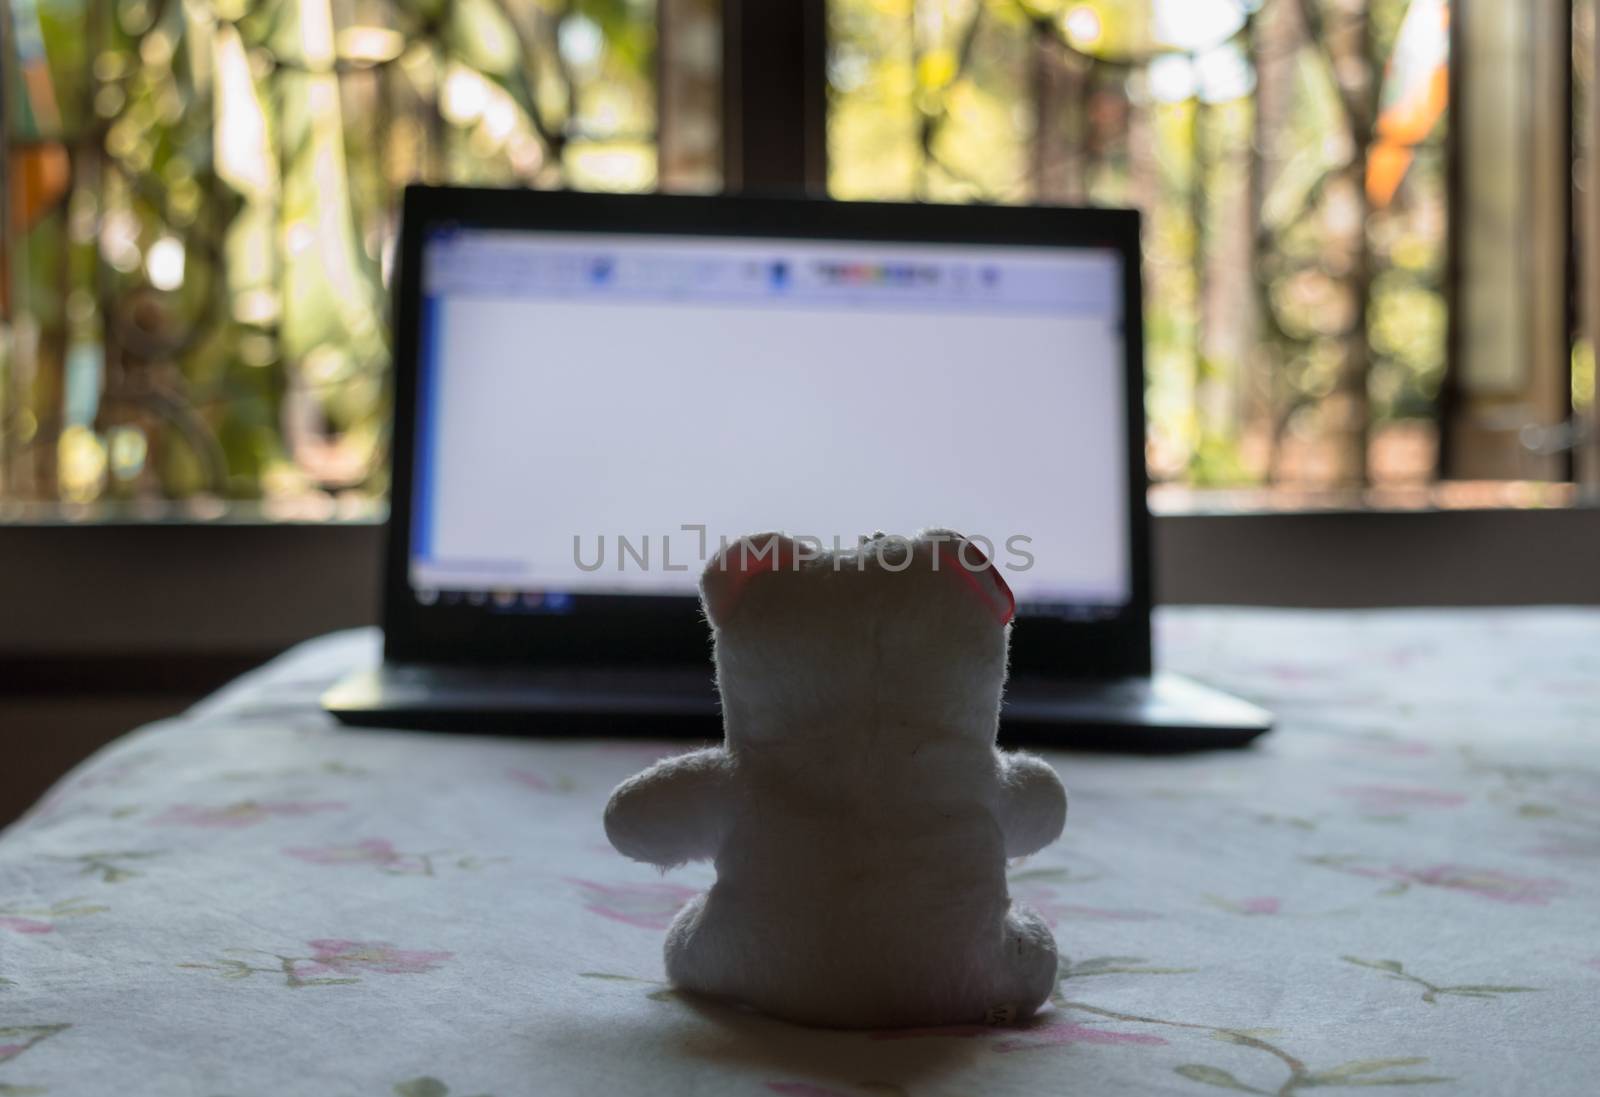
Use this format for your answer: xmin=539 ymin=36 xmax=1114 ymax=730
xmin=408 ymin=227 xmax=1133 ymax=619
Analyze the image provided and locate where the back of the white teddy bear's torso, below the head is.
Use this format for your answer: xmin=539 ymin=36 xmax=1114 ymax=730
xmin=669 ymin=777 xmax=1010 ymax=1025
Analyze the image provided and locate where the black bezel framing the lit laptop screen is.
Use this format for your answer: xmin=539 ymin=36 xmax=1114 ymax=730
xmin=382 ymin=185 xmax=1150 ymax=678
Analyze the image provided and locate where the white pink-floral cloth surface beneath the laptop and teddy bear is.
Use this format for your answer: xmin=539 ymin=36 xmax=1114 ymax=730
xmin=0 ymin=609 xmax=1600 ymax=1097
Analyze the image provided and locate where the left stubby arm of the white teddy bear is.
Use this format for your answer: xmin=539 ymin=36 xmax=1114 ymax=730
xmin=605 ymin=747 xmax=733 ymax=868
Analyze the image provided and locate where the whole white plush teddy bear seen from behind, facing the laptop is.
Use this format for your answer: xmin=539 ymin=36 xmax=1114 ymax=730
xmin=605 ymin=531 xmax=1067 ymax=1028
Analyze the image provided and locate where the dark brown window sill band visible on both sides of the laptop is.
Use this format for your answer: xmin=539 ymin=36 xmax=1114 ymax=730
xmin=0 ymin=504 xmax=1600 ymax=674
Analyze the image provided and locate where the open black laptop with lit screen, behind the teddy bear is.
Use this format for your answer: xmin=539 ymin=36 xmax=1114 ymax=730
xmin=323 ymin=187 xmax=1270 ymax=750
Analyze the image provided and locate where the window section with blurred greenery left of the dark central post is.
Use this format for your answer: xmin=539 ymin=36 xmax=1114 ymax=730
xmin=0 ymin=0 xmax=658 ymax=518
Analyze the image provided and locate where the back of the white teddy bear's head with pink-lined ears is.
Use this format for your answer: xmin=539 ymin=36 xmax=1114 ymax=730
xmin=701 ymin=529 xmax=1014 ymax=747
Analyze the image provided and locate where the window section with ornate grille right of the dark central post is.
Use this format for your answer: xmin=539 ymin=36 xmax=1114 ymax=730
xmin=829 ymin=0 xmax=1450 ymax=508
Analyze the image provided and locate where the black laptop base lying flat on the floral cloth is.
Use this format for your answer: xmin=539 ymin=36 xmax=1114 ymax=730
xmin=322 ymin=664 xmax=1272 ymax=753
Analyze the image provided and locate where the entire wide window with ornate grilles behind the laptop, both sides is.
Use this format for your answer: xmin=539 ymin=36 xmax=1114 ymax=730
xmin=0 ymin=0 xmax=1600 ymax=518
